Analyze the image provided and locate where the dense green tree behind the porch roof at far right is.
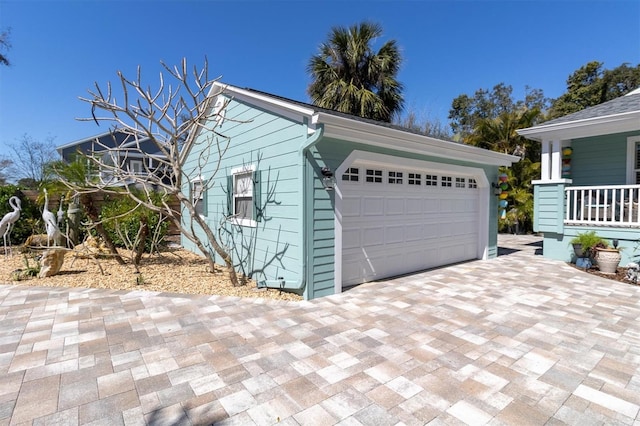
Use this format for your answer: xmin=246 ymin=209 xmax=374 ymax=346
xmin=547 ymin=61 xmax=640 ymax=120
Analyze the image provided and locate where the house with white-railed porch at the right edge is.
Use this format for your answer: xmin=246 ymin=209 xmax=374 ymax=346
xmin=518 ymin=89 xmax=640 ymax=265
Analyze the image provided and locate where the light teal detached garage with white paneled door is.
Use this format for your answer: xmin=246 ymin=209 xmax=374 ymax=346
xmin=182 ymin=82 xmax=519 ymax=299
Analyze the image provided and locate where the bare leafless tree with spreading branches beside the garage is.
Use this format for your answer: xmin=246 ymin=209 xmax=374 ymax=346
xmin=54 ymin=59 xmax=239 ymax=286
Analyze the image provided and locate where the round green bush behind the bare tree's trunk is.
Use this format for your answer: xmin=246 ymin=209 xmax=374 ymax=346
xmin=100 ymin=197 xmax=169 ymax=253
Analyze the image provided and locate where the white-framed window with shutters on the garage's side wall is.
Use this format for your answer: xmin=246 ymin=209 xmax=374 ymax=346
xmin=227 ymin=166 xmax=262 ymax=226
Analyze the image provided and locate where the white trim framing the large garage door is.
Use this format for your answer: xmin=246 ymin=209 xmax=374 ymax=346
xmin=334 ymin=150 xmax=491 ymax=293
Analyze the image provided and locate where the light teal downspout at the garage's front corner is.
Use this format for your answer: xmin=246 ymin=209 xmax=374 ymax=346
xmin=258 ymin=115 xmax=324 ymax=290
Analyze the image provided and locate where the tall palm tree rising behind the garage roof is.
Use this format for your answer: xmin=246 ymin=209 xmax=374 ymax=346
xmin=307 ymin=22 xmax=404 ymax=122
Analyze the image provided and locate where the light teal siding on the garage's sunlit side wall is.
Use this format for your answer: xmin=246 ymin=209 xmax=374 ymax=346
xmin=183 ymin=101 xmax=306 ymax=283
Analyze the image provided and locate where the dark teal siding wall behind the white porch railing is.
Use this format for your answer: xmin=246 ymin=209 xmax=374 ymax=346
xmin=571 ymin=132 xmax=638 ymax=186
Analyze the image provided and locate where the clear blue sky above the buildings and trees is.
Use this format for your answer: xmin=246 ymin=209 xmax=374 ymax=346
xmin=0 ymin=0 xmax=640 ymax=155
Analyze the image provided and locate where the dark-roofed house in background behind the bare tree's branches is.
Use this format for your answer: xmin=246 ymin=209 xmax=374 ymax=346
xmin=56 ymin=130 xmax=170 ymax=185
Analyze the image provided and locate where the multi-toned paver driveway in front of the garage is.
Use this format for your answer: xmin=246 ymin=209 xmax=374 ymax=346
xmin=0 ymin=236 xmax=640 ymax=426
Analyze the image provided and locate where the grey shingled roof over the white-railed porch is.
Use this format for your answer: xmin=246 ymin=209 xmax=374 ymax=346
xmin=517 ymin=88 xmax=640 ymax=141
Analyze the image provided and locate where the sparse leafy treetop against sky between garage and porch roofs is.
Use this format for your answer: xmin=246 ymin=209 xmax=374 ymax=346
xmin=449 ymin=83 xmax=549 ymax=142
